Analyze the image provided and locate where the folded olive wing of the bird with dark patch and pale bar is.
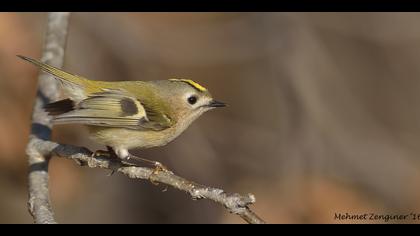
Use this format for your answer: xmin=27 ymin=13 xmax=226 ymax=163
xmin=46 ymin=89 xmax=171 ymax=130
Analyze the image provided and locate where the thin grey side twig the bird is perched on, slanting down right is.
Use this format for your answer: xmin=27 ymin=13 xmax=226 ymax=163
xmin=33 ymin=139 xmax=265 ymax=224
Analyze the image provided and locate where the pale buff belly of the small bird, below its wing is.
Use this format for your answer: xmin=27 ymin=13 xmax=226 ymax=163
xmin=88 ymin=126 xmax=177 ymax=149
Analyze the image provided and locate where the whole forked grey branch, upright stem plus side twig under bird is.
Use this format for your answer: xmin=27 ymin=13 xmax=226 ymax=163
xmin=26 ymin=13 xmax=264 ymax=223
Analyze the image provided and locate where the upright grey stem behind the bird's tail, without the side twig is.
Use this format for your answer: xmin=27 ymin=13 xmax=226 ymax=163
xmin=26 ymin=13 xmax=70 ymax=223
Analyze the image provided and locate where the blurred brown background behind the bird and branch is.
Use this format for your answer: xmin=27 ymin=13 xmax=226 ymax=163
xmin=0 ymin=13 xmax=420 ymax=223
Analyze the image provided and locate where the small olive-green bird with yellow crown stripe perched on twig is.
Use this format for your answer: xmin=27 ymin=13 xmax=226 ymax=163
xmin=18 ymin=55 xmax=226 ymax=165
